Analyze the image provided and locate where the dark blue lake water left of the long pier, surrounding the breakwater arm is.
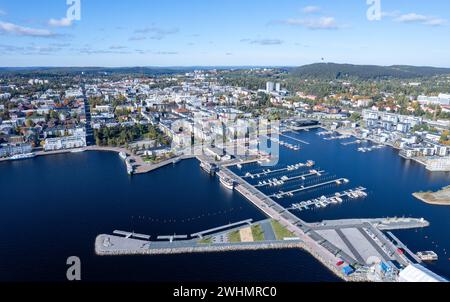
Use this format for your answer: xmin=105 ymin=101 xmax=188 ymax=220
xmin=0 ymin=153 xmax=337 ymax=281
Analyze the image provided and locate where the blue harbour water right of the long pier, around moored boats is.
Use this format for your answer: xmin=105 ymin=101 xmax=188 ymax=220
xmin=233 ymin=130 xmax=450 ymax=278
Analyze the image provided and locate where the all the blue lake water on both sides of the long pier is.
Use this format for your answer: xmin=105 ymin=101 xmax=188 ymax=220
xmin=0 ymin=131 xmax=450 ymax=281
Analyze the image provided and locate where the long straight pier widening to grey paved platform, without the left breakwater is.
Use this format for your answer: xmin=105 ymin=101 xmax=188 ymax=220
xmin=218 ymin=160 xmax=429 ymax=281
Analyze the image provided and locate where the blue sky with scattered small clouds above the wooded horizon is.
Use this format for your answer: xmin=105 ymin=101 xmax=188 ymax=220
xmin=0 ymin=0 xmax=450 ymax=67
